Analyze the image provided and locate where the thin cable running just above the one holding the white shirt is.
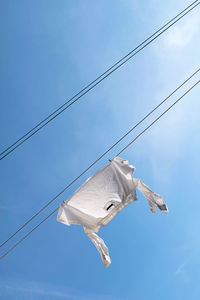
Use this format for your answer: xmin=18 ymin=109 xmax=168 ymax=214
xmin=0 ymin=68 xmax=200 ymax=253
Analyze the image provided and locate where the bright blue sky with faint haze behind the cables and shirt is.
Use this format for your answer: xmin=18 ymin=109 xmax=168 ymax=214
xmin=0 ymin=0 xmax=200 ymax=300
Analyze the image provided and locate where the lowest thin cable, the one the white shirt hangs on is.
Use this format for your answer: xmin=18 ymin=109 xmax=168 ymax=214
xmin=0 ymin=80 xmax=200 ymax=260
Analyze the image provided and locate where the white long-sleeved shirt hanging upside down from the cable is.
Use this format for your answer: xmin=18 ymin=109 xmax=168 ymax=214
xmin=57 ymin=157 xmax=168 ymax=267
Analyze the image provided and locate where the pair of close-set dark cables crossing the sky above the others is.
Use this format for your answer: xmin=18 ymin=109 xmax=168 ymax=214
xmin=0 ymin=0 xmax=200 ymax=160
